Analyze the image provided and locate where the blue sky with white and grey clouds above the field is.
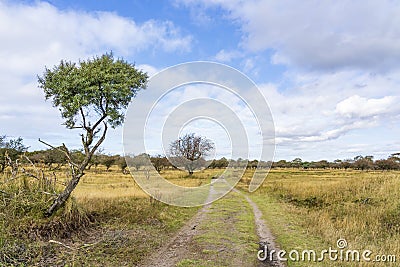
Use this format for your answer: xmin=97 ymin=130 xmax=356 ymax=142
xmin=0 ymin=0 xmax=400 ymax=160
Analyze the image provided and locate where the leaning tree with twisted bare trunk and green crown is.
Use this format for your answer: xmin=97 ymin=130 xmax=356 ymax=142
xmin=38 ymin=53 xmax=148 ymax=216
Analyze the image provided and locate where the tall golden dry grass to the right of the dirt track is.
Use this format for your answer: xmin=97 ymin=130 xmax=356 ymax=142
xmin=241 ymin=169 xmax=400 ymax=264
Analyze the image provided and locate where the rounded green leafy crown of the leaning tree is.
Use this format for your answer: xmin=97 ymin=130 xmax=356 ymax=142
xmin=38 ymin=53 xmax=147 ymax=128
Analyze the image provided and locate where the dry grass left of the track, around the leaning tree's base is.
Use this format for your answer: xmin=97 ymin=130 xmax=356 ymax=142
xmin=0 ymin=167 xmax=208 ymax=266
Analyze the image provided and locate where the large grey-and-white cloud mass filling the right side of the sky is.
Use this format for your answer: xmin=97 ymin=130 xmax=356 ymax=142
xmin=177 ymin=0 xmax=400 ymax=159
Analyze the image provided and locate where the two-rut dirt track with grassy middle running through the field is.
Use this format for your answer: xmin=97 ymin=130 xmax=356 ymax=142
xmin=139 ymin=180 xmax=284 ymax=267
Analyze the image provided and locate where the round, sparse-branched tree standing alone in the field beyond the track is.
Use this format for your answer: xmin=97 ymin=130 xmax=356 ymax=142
xmin=169 ymin=133 xmax=214 ymax=175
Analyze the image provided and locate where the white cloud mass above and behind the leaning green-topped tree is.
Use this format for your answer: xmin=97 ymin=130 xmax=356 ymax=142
xmin=0 ymin=0 xmax=192 ymax=152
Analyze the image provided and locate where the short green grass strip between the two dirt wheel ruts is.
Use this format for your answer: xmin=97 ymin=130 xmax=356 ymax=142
xmin=178 ymin=192 xmax=258 ymax=266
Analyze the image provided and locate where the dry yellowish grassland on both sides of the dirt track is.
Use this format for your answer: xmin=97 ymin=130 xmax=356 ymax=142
xmin=0 ymin=167 xmax=400 ymax=266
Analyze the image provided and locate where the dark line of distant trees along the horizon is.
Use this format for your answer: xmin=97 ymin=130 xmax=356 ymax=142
xmin=0 ymin=135 xmax=400 ymax=173
